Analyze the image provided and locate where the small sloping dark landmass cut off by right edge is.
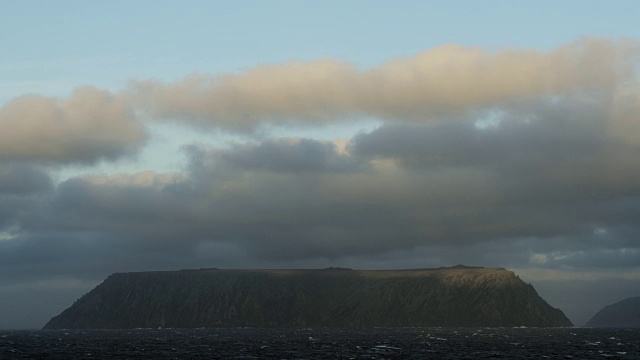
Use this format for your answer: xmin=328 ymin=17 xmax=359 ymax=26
xmin=586 ymin=296 xmax=640 ymax=328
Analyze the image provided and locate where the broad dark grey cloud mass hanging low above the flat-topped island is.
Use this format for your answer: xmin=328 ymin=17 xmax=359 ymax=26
xmin=6 ymin=93 xmax=640 ymax=276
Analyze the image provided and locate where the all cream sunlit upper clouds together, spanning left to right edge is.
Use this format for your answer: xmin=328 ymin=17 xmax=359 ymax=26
xmin=0 ymin=39 xmax=640 ymax=165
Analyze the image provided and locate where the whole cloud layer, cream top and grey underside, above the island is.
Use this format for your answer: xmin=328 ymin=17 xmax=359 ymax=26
xmin=0 ymin=39 xmax=640 ymax=290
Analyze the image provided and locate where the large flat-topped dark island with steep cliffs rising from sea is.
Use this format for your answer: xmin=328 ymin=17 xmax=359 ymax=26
xmin=45 ymin=267 xmax=571 ymax=329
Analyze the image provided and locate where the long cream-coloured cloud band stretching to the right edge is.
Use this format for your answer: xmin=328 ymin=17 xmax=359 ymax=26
xmin=127 ymin=39 xmax=638 ymax=131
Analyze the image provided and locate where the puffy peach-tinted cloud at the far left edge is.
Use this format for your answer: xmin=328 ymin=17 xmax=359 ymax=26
xmin=0 ymin=87 xmax=146 ymax=164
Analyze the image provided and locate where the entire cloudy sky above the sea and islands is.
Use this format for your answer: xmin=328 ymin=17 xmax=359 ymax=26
xmin=0 ymin=0 xmax=640 ymax=329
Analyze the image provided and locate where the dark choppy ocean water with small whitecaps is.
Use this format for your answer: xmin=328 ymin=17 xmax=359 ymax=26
xmin=0 ymin=328 xmax=640 ymax=359
